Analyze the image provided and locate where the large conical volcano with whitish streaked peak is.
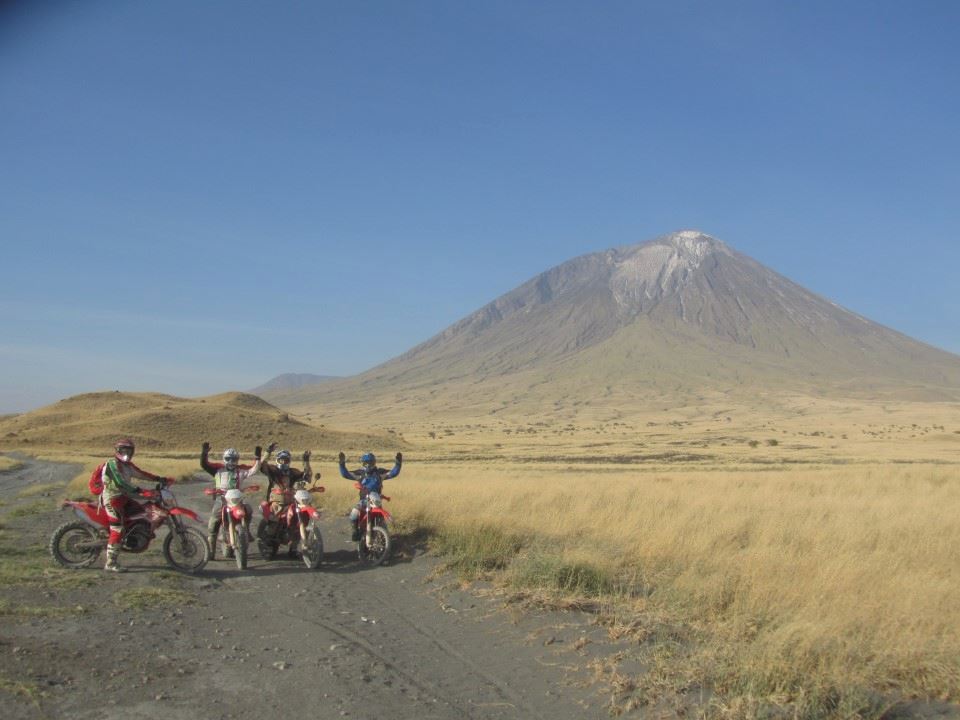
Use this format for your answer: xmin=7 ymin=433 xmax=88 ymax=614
xmin=267 ymin=231 xmax=960 ymax=422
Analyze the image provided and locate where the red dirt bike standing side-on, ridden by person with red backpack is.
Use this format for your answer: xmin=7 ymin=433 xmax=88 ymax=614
xmin=50 ymin=478 xmax=210 ymax=573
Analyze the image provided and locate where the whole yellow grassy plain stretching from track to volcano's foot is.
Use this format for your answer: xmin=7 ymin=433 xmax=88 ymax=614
xmin=0 ymin=396 xmax=960 ymax=718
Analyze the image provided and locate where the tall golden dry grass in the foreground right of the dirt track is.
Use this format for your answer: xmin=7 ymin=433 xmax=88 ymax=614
xmin=385 ymin=465 xmax=960 ymax=716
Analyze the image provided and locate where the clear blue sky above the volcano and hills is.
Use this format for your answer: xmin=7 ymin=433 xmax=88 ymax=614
xmin=0 ymin=0 xmax=960 ymax=412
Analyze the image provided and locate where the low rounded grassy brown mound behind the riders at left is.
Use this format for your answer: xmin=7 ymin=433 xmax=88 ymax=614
xmin=0 ymin=392 xmax=403 ymax=452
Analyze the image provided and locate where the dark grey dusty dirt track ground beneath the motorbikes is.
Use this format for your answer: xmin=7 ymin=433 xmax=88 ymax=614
xmin=0 ymin=458 xmax=611 ymax=720
